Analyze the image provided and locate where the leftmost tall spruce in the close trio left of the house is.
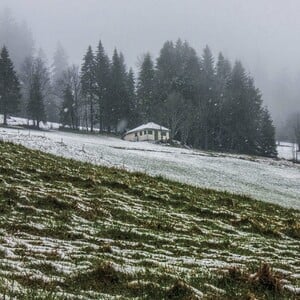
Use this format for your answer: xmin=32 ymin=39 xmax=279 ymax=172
xmin=81 ymin=46 xmax=97 ymax=132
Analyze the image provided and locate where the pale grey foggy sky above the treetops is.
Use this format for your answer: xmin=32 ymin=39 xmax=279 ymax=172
xmin=0 ymin=0 xmax=300 ymax=125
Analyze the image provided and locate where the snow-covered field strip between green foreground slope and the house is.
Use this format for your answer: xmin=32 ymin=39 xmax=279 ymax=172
xmin=0 ymin=128 xmax=300 ymax=209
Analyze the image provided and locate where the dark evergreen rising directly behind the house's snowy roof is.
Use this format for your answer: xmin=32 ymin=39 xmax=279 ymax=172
xmin=137 ymin=53 xmax=155 ymax=123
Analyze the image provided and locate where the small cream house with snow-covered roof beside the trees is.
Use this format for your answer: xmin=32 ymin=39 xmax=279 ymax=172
xmin=123 ymin=122 xmax=170 ymax=142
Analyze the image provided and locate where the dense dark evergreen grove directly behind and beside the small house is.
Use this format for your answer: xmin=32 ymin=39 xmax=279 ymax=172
xmin=77 ymin=40 xmax=277 ymax=156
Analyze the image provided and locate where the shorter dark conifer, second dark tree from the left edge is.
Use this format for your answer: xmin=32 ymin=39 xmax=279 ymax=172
xmin=27 ymin=72 xmax=46 ymax=128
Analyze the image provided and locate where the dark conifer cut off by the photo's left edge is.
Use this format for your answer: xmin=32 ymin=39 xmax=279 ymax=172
xmin=0 ymin=47 xmax=21 ymax=125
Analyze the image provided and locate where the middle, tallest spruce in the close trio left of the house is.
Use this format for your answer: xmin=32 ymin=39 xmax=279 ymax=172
xmin=96 ymin=41 xmax=111 ymax=131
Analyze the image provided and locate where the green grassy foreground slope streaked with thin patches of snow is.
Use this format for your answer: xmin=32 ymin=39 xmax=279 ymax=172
xmin=0 ymin=143 xmax=300 ymax=299
